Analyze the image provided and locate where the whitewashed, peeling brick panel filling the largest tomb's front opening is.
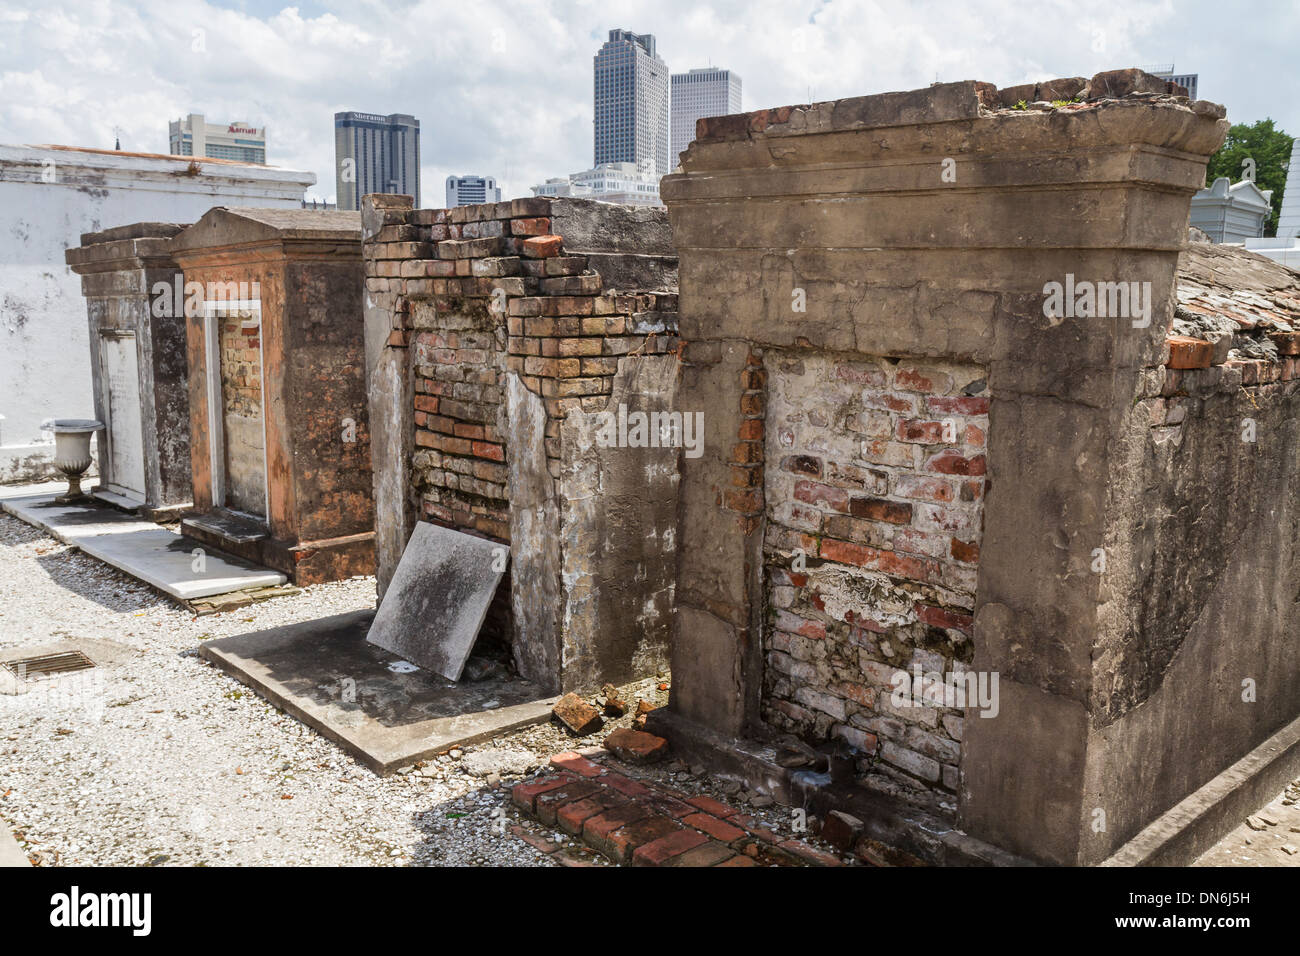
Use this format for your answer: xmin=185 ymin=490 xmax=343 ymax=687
xmin=762 ymin=351 xmax=988 ymax=805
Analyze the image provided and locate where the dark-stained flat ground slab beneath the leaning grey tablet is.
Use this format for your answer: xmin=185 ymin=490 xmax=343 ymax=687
xmin=199 ymin=611 xmax=559 ymax=774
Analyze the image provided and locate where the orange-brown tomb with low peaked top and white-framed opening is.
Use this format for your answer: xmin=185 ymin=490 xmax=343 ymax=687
xmin=170 ymin=207 xmax=374 ymax=584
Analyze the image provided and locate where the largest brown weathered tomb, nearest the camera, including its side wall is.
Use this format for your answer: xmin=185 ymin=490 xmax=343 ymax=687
xmin=655 ymin=70 xmax=1300 ymax=864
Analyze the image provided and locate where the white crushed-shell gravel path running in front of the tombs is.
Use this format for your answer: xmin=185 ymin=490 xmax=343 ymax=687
xmin=0 ymin=514 xmax=821 ymax=866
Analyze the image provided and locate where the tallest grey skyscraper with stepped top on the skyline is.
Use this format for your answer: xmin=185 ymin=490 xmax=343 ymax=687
xmin=593 ymin=30 xmax=672 ymax=176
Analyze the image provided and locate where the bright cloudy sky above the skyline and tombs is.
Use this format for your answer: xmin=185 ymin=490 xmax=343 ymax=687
xmin=0 ymin=0 xmax=1300 ymax=206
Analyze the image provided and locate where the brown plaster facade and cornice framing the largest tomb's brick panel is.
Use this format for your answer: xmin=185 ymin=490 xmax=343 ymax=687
xmin=662 ymin=74 xmax=1227 ymax=864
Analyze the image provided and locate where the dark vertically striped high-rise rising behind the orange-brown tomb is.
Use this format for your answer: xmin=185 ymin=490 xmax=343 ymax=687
xmin=334 ymin=112 xmax=420 ymax=209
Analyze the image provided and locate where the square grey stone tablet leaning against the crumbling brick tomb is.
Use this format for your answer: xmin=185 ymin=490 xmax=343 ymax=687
xmin=367 ymin=522 xmax=510 ymax=680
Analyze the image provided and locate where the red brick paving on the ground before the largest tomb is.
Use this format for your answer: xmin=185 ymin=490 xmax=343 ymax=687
xmin=511 ymin=753 xmax=840 ymax=866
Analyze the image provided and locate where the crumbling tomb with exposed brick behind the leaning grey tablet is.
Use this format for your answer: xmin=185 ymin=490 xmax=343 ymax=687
xmin=365 ymin=196 xmax=677 ymax=689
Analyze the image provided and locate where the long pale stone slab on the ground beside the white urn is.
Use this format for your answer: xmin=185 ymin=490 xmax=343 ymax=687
xmin=0 ymin=493 xmax=287 ymax=601
